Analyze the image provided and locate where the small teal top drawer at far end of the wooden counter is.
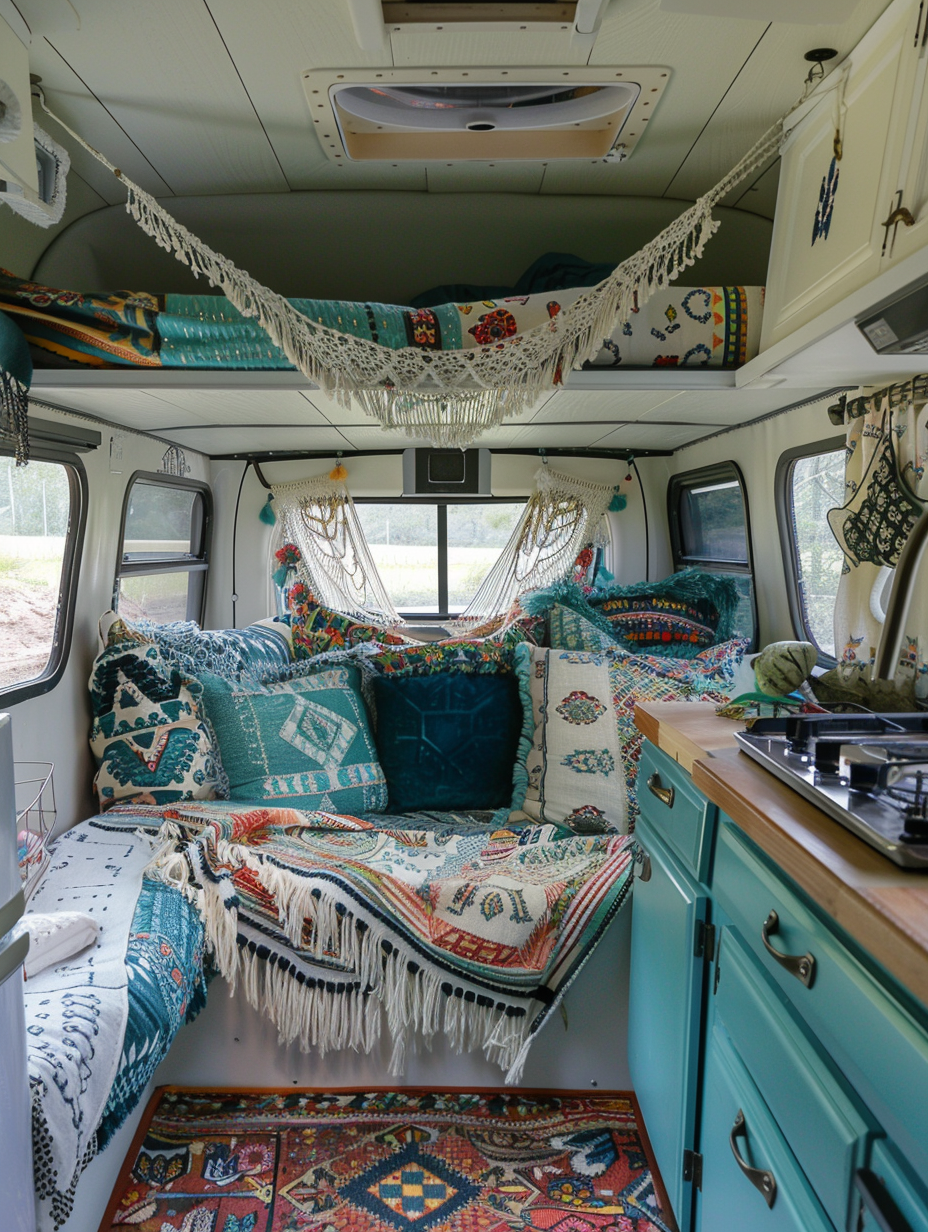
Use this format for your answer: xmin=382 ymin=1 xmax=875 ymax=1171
xmin=637 ymin=743 xmax=716 ymax=881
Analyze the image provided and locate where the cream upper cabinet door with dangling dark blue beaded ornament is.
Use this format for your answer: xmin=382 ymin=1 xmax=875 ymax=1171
xmin=760 ymin=0 xmax=911 ymax=350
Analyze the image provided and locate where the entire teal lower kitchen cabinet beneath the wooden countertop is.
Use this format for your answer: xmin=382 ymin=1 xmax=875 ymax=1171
xmin=629 ymin=743 xmax=928 ymax=1232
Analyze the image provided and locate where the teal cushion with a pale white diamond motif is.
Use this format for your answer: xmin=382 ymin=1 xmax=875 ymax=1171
xmin=202 ymin=665 xmax=387 ymax=813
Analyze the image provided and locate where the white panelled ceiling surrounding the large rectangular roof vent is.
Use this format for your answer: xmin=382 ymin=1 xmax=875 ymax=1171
xmin=9 ymin=0 xmax=887 ymax=209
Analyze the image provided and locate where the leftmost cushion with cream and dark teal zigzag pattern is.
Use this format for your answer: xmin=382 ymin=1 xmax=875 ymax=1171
xmin=90 ymin=620 xmax=224 ymax=808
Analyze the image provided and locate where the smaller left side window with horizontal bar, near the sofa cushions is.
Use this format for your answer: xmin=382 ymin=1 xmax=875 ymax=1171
xmin=113 ymin=471 xmax=212 ymax=625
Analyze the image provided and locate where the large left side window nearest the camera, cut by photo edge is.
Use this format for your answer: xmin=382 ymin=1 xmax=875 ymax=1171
xmin=0 ymin=448 xmax=86 ymax=706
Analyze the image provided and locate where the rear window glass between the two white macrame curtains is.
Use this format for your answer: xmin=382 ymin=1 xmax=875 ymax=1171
xmin=355 ymin=498 xmax=525 ymax=620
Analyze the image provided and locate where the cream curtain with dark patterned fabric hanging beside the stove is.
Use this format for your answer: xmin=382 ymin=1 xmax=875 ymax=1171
xmin=827 ymin=377 xmax=928 ymax=699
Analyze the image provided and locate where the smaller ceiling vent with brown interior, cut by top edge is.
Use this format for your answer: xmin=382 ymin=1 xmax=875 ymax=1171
xmin=346 ymin=0 xmax=609 ymax=52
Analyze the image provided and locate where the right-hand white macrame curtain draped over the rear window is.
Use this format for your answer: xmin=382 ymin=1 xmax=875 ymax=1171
xmin=455 ymin=466 xmax=615 ymax=631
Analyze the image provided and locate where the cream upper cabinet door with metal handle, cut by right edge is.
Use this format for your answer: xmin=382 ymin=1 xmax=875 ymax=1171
xmin=879 ymin=0 xmax=928 ymax=269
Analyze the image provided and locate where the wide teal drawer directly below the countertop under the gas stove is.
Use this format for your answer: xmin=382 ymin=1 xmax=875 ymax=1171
xmin=714 ymin=818 xmax=928 ymax=1175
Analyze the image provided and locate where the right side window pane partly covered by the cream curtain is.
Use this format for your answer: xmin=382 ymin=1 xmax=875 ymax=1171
xmin=776 ymin=441 xmax=845 ymax=662
